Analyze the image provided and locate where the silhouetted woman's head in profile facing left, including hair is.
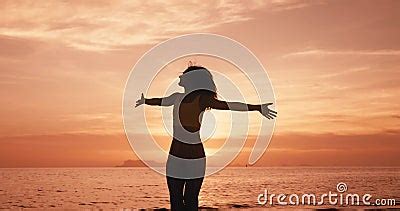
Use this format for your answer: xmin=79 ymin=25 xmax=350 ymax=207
xmin=179 ymin=66 xmax=217 ymax=93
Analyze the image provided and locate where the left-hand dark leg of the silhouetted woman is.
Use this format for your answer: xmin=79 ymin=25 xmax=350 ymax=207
xmin=167 ymin=176 xmax=185 ymax=211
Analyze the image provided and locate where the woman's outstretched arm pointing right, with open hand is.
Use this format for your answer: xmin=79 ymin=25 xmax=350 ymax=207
xmin=208 ymin=98 xmax=277 ymax=119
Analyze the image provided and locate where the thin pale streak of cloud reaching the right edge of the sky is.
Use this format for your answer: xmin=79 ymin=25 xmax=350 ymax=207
xmin=282 ymin=49 xmax=400 ymax=58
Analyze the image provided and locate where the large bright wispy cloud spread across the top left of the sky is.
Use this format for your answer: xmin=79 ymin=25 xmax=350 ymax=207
xmin=0 ymin=0 xmax=318 ymax=50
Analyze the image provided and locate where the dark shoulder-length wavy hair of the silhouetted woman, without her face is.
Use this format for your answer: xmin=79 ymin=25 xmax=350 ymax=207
xmin=183 ymin=66 xmax=217 ymax=109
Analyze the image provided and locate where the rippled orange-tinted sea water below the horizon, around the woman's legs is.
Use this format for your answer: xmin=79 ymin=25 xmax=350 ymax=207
xmin=0 ymin=167 xmax=400 ymax=209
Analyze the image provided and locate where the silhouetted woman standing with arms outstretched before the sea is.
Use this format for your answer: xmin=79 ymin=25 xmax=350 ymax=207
xmin=136 ymin=66 xmax=276 ymax=211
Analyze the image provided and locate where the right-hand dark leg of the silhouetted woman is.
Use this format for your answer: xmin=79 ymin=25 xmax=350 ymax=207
xmin=183 ymin=177 xmax=204 ymax=211
